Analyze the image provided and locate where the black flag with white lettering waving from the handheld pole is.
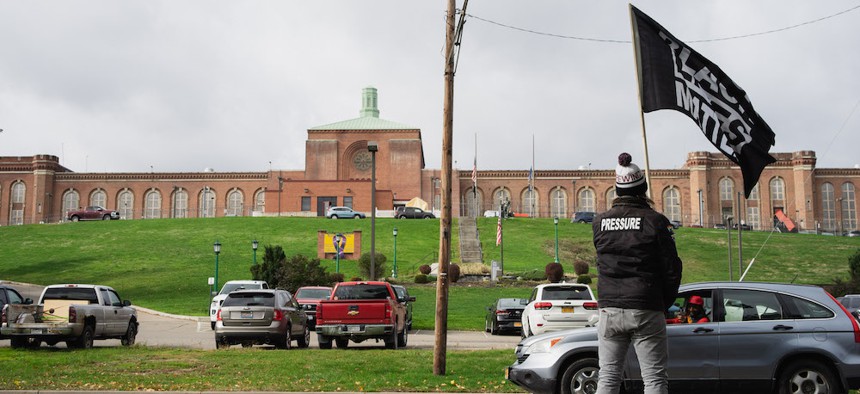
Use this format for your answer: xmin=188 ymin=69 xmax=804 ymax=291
xmin=630 ymin=4 xmax=776 ymax=198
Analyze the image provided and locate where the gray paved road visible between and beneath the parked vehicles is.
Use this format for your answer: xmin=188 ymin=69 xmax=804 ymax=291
xmin=0 ymin=285 xmax=520 ymax=354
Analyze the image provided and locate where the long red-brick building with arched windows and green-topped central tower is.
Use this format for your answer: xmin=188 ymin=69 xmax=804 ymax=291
xmin=0 ymin=88 xmax=860 ymax=233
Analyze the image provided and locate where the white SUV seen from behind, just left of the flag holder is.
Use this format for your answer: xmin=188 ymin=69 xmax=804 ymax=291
xmin=522 ymin=283 xmax=599 ymax=337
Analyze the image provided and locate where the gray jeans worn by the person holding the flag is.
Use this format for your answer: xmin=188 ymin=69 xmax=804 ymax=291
xmin=597 ymin=308 xmax=669 ymax=394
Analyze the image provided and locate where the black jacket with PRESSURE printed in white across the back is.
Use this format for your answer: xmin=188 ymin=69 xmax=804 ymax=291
xmin=592 ymin=196 xmax=682 ymax=311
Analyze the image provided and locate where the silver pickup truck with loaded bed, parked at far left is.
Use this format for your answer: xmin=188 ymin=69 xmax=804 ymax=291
xmin=0 ymin=284 xmax=138 ymax=349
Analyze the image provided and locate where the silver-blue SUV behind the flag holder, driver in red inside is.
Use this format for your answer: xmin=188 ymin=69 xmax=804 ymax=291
xmin=506 ymin=282 xmax=860 ymax=393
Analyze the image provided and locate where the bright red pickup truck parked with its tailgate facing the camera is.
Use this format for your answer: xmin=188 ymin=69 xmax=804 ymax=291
xmin=316 ymin=282 xmax=408 ymax=349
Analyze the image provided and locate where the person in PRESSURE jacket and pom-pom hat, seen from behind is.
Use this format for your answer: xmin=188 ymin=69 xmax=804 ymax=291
xmin=592 ymin=153 xmax=681 ymax=394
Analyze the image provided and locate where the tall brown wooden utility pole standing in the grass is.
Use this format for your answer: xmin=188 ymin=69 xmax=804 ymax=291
xmin=433 ymin=0 xmax=468 ymax=375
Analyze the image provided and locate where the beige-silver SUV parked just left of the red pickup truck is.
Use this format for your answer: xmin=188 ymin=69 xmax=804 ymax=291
xmin=215 ymin=289 xmax=311 ymax=349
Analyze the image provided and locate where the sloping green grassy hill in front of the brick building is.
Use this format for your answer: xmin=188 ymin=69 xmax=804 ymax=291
xmin=0 ymin=217 xmax=860 ymax=328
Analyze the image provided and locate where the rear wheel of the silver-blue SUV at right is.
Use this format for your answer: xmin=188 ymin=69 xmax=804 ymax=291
xmin=777 ymin=360 xmax=841 ymax=394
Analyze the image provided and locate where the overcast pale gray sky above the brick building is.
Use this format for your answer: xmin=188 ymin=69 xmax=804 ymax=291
xmin=0 ymin=0 xmax=860 ymax=172
